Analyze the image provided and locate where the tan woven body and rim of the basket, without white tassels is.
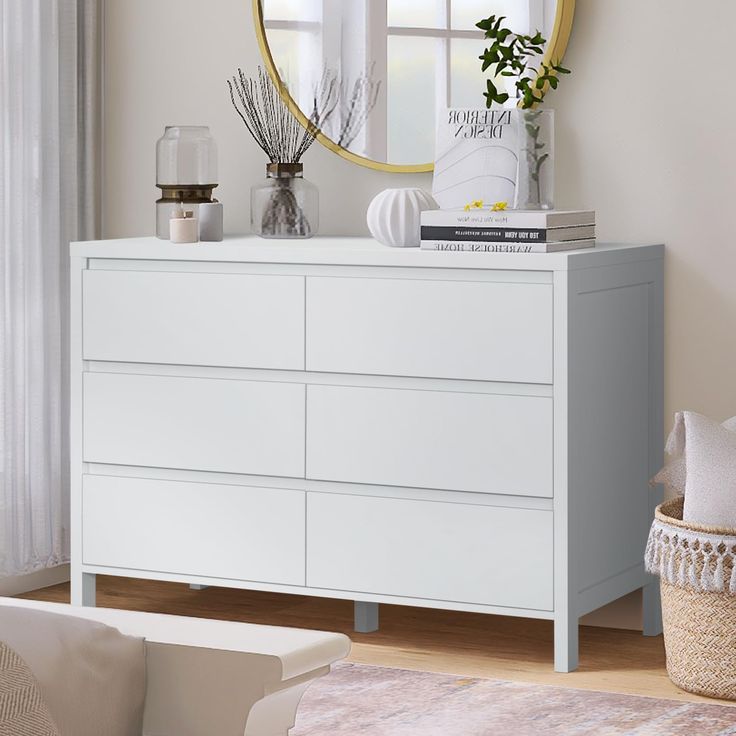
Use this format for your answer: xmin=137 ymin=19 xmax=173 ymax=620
xmin=655 ymin=497 xmax=736 ymax=700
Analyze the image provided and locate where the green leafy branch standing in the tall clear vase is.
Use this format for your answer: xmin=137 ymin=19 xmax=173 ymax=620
xmin=476 ymin=15 xmax=570 ymax=210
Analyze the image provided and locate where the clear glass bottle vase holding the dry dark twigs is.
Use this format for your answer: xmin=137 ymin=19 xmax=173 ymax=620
xmin=250 ymin=164 xmax=319 ymax=238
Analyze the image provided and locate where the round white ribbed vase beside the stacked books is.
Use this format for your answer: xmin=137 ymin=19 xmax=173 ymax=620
xmin=367 ymin=189 xmax=439 ymax=248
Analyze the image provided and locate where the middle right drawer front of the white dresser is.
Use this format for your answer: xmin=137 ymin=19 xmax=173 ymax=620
xmin=307 ymin=386 xmax=552 ymax=496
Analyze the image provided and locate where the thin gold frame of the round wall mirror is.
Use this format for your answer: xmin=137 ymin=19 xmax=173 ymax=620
xmin=252 ymin=0 xmax=575 ymax=174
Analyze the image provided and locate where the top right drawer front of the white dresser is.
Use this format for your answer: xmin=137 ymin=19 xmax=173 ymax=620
xmin=306 ymin=277 xmax=552 ymax=383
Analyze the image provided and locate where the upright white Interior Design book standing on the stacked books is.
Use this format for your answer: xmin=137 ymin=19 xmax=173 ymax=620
xmin=432 ymin=108 xmax=521 ymax=208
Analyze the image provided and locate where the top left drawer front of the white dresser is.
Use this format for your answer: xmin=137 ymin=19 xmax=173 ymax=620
xmin=83 ymin=270 xmax=304 ymax=370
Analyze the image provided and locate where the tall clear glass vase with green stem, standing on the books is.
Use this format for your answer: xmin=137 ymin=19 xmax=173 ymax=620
xmin=514 ymin=110 xmax=555 ymax=210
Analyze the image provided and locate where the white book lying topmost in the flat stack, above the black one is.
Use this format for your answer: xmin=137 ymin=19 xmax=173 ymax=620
xmin=421 ymin=208 xmax=595 ymax=229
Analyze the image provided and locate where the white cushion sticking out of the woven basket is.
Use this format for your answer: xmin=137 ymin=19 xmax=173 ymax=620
xmin=655 ymin=411 xmax=736 ymax=529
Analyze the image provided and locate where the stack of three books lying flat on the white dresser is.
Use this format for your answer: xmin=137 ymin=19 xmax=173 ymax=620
xmin=421 ymin=209 xmax=595 ymax=253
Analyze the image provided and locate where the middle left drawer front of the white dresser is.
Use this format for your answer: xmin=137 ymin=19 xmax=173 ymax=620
xmin=83 ymin=373 xmax=304 ymax=477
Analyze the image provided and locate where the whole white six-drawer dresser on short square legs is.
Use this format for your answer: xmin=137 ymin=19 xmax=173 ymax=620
xmin=71 ymin=238 xmax=664 ymax=671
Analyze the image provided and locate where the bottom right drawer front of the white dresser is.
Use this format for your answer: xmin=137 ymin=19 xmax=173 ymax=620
xmin=307 ymin=493 xmax=552 ymax=611
